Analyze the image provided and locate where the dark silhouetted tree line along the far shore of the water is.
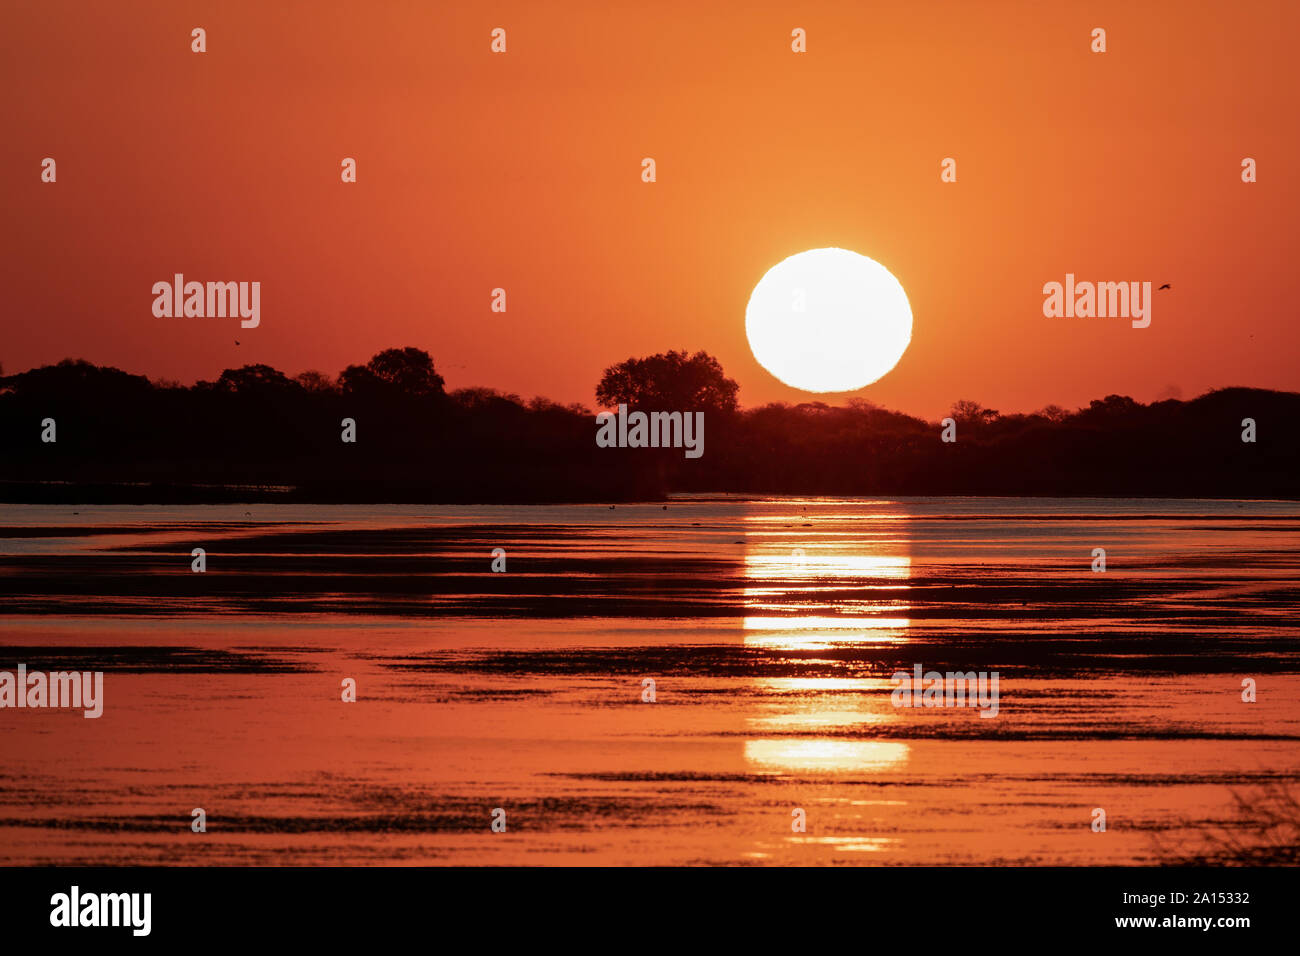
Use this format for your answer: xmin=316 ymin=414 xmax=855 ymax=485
xmin=0 ymin=347 xmax=1300 ymax=502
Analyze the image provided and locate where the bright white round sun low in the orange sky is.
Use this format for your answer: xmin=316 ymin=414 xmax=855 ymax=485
xmin=745 ymin=248 xmax=911 ymax=392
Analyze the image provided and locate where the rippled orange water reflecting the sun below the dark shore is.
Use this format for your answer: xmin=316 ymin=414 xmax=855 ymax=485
xmin=0 ymin=498 xmax=1300 ymax=864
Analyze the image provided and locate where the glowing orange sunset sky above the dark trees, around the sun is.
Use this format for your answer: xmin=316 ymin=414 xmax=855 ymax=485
xmin=0 ymin=0 xmax=1300 ymax=416
